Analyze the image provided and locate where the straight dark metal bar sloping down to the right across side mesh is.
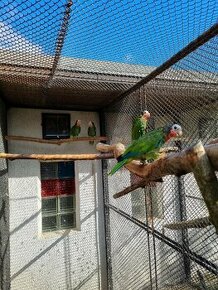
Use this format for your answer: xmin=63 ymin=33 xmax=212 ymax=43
xmin=108 ymin=204 xmax=218 ymax=275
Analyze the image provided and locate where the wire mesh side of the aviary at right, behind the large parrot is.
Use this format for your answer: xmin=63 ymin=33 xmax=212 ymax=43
xmin=105 ymin=32 xmax=218 ymax=289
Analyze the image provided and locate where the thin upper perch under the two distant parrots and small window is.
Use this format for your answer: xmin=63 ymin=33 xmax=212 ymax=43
xmin=5 ymin=136 xmax=108 ymax=145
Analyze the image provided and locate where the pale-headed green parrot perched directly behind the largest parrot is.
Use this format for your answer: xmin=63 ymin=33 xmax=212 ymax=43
xmin=132 ymin=111 xmax=150 ymax=141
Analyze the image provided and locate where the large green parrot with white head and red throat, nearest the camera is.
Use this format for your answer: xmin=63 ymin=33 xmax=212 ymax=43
xmin=109 ymin=124 xmax=182 ymax=175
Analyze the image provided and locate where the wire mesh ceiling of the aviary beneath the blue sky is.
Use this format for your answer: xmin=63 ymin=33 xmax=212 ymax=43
xmin=0 ymin=0 xmax=218 ymax=110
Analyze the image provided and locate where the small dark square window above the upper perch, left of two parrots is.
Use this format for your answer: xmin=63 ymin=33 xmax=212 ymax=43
xmin=42 ymin=113 xmax=70 ymax=139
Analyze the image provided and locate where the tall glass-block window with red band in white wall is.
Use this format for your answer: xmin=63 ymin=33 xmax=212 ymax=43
xmin=41 ymin=161 xmax=76 ymax=232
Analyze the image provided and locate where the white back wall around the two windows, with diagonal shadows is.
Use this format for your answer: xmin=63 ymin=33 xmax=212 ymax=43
xmin=8 ymin=108 xmax=107 ymax=290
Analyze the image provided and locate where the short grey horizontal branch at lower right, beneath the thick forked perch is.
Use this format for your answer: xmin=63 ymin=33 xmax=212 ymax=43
xmin=164 ymin=216 xmax=212 ymax=230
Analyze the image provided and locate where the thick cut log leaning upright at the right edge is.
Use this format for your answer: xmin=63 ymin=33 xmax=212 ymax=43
xmin=191 ymin=142 xmax=218 ymax=234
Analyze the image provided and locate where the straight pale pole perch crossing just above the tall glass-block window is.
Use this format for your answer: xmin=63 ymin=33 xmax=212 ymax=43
xmin=0 ymin=153 xmax=113 ymax=161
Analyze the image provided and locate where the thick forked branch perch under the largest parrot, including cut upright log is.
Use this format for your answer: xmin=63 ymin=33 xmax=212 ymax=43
xmin=101 ymin=142 xmax=218 ymax=234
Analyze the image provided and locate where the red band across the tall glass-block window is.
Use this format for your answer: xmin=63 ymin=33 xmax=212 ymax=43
xmin=41 ymin=179 xmax=75 ymax=197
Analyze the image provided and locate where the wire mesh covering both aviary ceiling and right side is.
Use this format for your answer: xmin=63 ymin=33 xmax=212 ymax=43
xmin=0 ymin=0 xmax=218 ymax=290
